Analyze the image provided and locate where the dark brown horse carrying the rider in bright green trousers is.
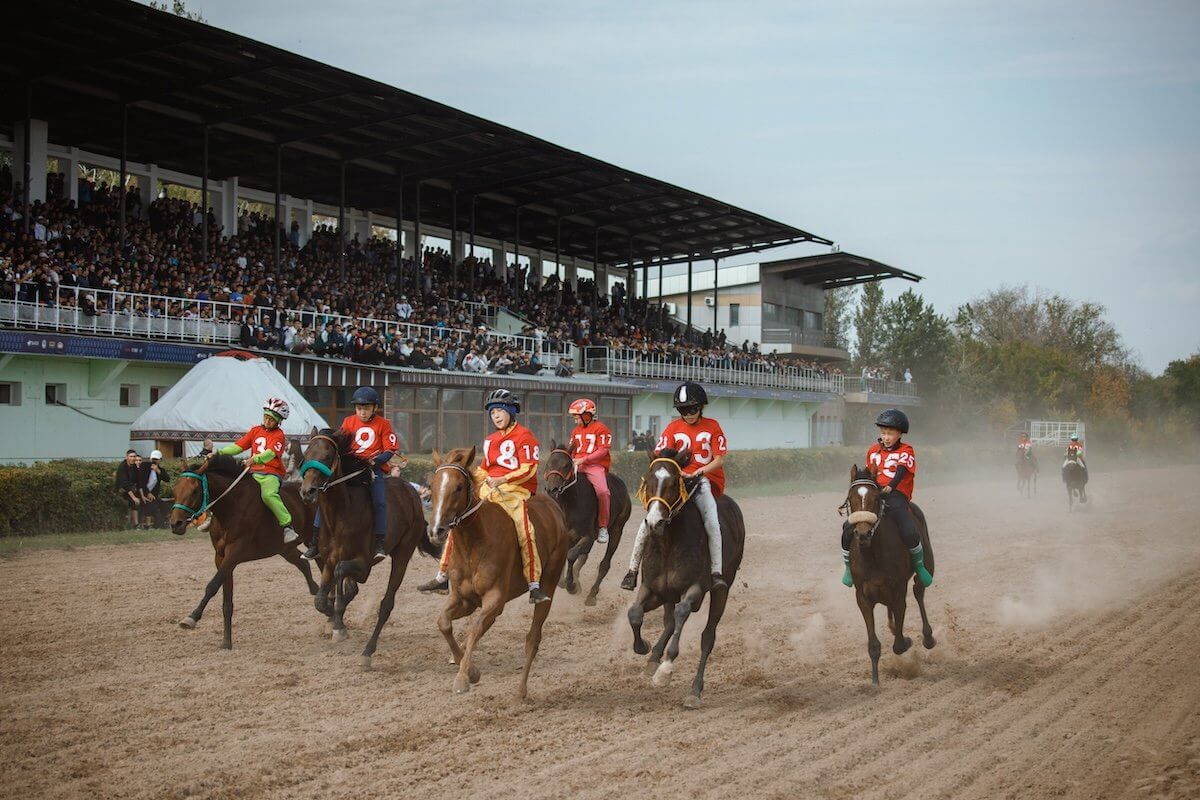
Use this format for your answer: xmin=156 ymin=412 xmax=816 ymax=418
xmin=170 ymin=456 xmax=317 ymax=650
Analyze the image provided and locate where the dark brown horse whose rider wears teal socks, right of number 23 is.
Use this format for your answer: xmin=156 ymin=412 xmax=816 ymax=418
xmin=840 ymin=464 xmax=937 ymax=686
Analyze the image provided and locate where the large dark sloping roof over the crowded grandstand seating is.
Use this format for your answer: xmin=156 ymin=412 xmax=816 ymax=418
xmin=0 ymin=0 xmax=832 ymax=266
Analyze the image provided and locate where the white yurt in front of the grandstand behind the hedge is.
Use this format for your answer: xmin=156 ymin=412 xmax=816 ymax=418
xmin=130 ymin=350 xmax=328 ymax=458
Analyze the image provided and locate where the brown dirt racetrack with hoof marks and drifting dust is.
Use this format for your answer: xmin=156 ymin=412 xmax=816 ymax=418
xmin=0 ymin=467 xmax=1200 ymax=800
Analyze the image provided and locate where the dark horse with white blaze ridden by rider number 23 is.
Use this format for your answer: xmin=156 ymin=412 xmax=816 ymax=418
xmin=629 ymin=447 xmax=746 ymax=709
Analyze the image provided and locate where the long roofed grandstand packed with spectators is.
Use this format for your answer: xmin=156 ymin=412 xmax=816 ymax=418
xmin=0 ymin=0 xmax=916 ymax=461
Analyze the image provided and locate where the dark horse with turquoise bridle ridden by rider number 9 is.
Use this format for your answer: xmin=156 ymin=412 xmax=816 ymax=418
xmin=300 ymin=429 xmax=437 ymax=669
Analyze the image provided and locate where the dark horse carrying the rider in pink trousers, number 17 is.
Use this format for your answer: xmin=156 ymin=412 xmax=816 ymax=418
xmin=542 ymin=441 xmax=632 ymax=606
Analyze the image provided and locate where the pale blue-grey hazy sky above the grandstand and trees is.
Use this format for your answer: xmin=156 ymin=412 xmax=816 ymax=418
xmin=180 ymin=0 xmax=1200 ymax=373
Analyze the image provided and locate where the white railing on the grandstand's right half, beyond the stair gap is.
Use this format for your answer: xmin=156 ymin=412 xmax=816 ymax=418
xmin=584 ymin=347 xmax=845 ymax=395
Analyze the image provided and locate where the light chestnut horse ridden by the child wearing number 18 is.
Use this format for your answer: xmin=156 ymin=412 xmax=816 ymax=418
xmin=428 ymin=447 xmax=570 ymax=698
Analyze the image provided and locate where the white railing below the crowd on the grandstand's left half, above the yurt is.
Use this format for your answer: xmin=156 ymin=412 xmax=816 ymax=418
xmin=0 ymin=285 xmax=577 ymax=363
